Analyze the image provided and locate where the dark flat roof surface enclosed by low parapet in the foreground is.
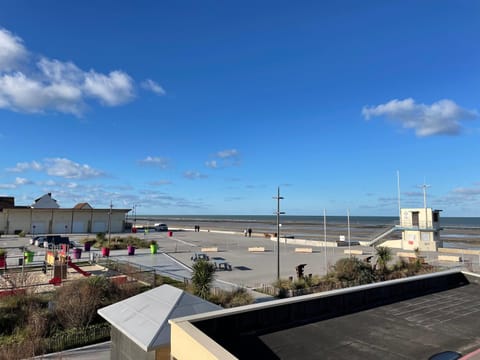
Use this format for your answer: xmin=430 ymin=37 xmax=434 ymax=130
xmin=209 ymin=276 xmax=480 ymax=360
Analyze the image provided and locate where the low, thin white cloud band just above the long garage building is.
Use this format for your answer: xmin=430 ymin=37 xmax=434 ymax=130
xmin=7 ymin=158 xmax=104 ymax=179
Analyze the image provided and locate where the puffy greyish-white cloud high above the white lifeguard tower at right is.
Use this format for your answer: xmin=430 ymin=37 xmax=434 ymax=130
xmin=362 ymin=98 xmax=478 ymax=137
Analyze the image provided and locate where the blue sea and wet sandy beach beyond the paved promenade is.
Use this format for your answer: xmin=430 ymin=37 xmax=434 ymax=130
xmin=127 ymin=215 xmax=480 ymax=249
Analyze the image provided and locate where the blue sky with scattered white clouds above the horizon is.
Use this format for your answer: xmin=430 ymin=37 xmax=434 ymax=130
xmin=0 ymin=0 xmax=480 ymax=216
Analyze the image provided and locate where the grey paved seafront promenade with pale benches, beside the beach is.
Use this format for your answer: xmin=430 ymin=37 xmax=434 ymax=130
xmin=0 ymin=228 xmax=480 ymax=289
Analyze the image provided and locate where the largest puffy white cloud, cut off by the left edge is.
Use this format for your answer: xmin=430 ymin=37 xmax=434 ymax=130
xmin=0 ymin=28 xmax=165 ymax=116
